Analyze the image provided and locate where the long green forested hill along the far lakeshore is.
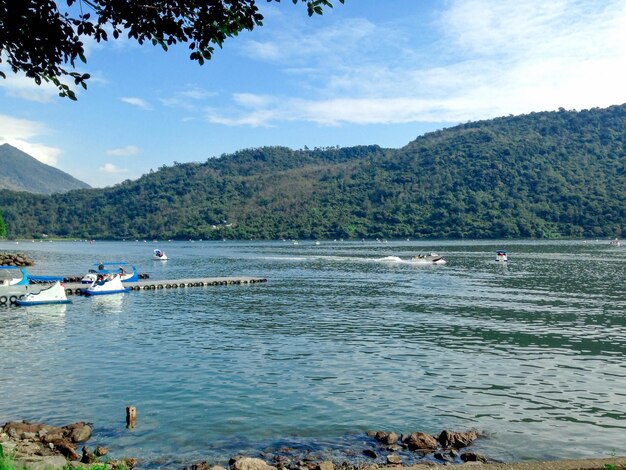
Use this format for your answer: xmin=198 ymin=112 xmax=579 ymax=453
xmin=0 ymin=105 xmax=626 ymax=239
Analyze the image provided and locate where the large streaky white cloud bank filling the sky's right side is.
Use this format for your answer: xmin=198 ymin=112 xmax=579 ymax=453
xmin=212 ymin=0 xmax=626 ymax=126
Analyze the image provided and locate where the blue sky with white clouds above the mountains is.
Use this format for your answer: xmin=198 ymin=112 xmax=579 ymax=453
xmin=0 ymin=0 xmax=626 ymax=187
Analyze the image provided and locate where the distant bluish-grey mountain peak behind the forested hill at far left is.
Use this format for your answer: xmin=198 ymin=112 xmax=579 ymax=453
xmin=0 ymin=144 xmax=90 ymax=194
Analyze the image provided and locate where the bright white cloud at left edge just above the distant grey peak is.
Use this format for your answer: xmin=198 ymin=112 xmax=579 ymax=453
xmin=0 ymin=114 xmax=61 ymax=166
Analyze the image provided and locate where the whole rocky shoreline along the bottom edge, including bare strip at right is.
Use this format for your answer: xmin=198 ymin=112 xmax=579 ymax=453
xmin=0 ymin=421 xmax=626 ymax=470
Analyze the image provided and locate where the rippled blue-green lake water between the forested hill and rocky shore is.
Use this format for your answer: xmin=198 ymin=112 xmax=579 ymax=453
xmin=0 ymin=240 xmax=626 ymax=466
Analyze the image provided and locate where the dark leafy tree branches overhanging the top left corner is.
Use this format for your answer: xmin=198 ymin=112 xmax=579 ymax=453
xmin=0 ymin=0 xmax=344 ymax=100
